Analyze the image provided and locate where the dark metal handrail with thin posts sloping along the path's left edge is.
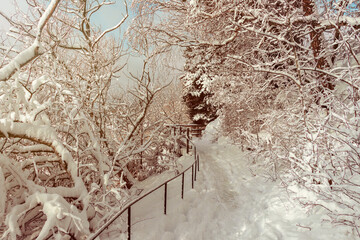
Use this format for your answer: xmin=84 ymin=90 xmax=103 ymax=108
xmin=88 ymin=126 xmax=200 ymax=240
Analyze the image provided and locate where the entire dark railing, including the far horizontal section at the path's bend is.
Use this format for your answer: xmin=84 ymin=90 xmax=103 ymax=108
xmin=87 ymin=124 xmax=203 ymax=240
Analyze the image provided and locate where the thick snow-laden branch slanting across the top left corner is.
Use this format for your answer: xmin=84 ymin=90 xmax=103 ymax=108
xmin=0 ymin=0 xmax=60 ymax=81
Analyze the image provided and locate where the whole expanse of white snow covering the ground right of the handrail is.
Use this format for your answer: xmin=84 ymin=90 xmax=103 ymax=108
xmin=96 ymin=127 xmax=356 ymax=240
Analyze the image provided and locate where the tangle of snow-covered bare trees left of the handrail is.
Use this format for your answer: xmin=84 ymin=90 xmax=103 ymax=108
xmin=0 ymin=0 xmax=177 ymax=239
